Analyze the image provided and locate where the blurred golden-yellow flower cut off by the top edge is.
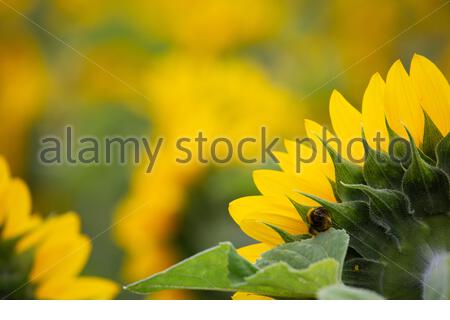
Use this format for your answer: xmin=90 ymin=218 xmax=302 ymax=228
xmin=126 ymin=0 xmax=288 ymax=53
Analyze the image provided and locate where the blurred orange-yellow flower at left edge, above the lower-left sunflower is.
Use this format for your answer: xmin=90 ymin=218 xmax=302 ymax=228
xmin=0 ymin=26 xmax=48 ymax=172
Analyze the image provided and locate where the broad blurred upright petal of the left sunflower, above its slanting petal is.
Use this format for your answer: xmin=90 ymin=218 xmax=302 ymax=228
xmin=3 ymin=179 xmax=32 ymax=239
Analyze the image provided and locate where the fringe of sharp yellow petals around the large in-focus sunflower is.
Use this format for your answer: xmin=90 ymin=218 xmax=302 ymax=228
xmin=229 ymin=54 xmax=450 ymax=298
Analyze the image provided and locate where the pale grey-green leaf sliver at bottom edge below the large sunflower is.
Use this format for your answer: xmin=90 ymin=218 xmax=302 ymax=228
xmin=317 ymin=284 xmax=384 ymax=300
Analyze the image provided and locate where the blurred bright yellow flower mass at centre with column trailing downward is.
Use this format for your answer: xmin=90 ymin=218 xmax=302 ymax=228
xmin=115 ymin=56 xmax=300 ymax=298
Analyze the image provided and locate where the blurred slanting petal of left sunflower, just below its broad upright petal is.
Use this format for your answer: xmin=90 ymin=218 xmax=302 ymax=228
xmin=16 ymin=212 xmax=81 ymax=252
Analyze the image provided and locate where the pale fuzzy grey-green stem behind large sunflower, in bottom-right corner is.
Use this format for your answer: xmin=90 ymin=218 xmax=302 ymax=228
xmin=423 ymin=253 xmax=450 ymax=300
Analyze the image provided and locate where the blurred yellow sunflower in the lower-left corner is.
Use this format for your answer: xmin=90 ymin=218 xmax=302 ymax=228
xmin=0 ymin=157 xmax=119 ymax=299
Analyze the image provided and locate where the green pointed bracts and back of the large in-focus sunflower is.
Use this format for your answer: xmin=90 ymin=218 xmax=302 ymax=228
xmin=297 ymin=128 xmax=450 ymax=299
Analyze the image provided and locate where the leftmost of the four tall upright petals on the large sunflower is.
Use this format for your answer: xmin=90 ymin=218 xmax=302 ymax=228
xmin=330 ymin=90 xmax=364 ymax=162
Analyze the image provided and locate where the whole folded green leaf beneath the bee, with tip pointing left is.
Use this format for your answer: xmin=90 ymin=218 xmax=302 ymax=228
xmin=126 ymin=229 xmax=368 ymax=298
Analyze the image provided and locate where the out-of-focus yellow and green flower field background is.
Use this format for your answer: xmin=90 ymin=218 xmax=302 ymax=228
xmin=0 ymin=0 xmax=450 ymax=299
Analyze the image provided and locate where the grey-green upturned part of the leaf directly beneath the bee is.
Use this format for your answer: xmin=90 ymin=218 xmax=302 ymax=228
xmin=256 ymin=229 xmax=349 ymax=277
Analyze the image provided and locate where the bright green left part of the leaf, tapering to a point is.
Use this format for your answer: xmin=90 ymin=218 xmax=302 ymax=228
xmin=125 ymin=243 xmax=257 ymax=294
